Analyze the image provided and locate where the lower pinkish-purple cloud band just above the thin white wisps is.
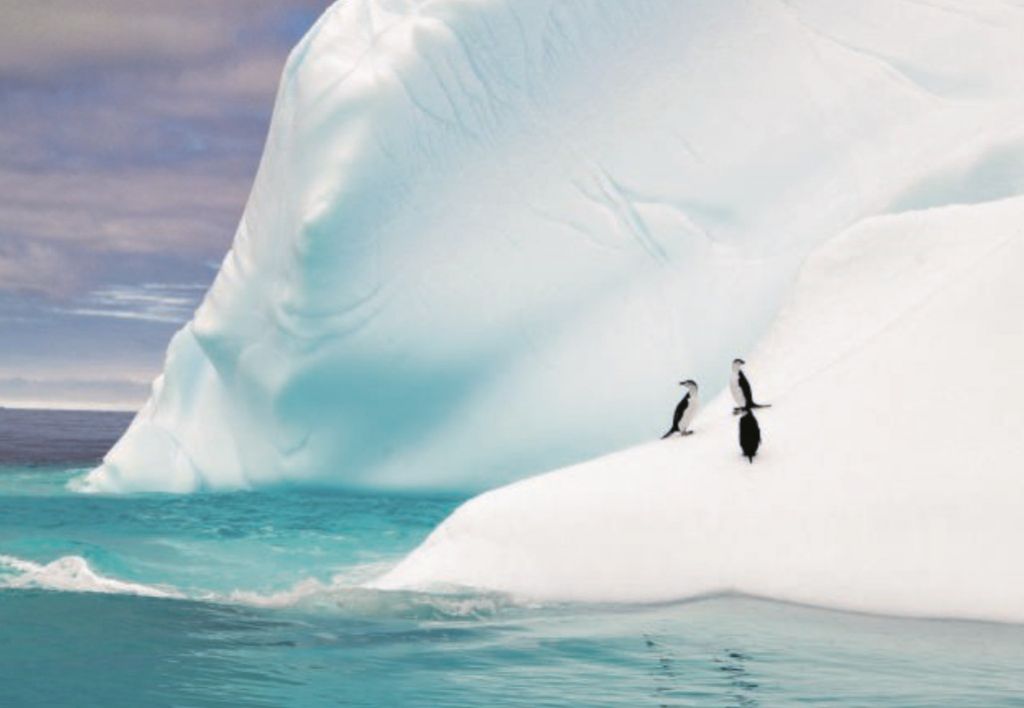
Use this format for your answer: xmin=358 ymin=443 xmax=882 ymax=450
xmin=0 ymin=163 xmax=249 ymax=299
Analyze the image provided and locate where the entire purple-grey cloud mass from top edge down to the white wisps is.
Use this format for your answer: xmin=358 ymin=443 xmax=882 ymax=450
xmin=0 ymin=0 xmax=328 ymax=299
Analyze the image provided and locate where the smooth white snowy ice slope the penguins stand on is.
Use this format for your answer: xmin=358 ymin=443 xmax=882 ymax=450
xmin=377 ymin=198 xmax=1024 ymax=621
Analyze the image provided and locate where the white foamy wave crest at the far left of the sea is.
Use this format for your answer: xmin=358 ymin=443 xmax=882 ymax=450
xmin=0 ymin=555 xmax=184 ymax=598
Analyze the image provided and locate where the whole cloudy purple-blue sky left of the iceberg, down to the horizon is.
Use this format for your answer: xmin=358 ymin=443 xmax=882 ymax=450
xmin=0 ymin=0 xmax=330 ymax=409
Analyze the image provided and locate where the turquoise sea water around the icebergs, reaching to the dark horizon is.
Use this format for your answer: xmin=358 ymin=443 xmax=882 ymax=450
xmin=0 ymin=411 xmax=1024 ymax=707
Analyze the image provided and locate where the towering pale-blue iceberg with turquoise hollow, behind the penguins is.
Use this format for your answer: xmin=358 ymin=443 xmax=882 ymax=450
xmin=87 ymin=0 xmax=1024 ymax=492
